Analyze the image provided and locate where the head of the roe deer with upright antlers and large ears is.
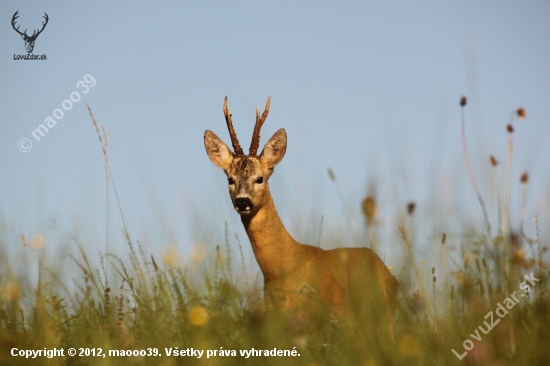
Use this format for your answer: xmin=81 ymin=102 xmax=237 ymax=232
xmin=204 ymin=97 xmax=286 ymax=215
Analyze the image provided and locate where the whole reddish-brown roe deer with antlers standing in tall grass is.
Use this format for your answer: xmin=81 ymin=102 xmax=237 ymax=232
xmin=204 ymin=97 xmax=397 ymax=328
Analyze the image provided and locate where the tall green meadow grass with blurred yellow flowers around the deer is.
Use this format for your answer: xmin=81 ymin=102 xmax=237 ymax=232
xmin=0 ymin=104 xmax=550 ymax=366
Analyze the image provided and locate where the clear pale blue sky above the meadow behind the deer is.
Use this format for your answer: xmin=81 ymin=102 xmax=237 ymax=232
xmin=0 ymin=1 xmax=550 ymax=270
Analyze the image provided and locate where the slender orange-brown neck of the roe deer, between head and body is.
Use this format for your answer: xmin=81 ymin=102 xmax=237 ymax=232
xmin=241 ymin=191 xmax=299 ymax=281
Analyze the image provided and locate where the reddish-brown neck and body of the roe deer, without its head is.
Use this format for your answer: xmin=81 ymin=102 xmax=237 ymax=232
xmin=241 ymin=190 xmax=397 ymax=320
